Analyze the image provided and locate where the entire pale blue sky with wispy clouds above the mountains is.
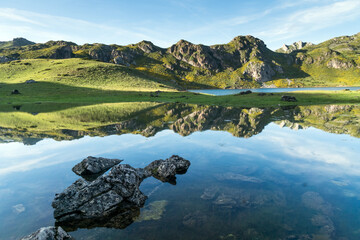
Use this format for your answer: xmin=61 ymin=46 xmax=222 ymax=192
xmin=0 ymin=0 xmax=360 ymax=50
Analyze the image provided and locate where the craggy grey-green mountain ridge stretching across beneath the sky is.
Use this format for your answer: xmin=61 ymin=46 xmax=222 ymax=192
xmin=0 ymin=33 xmax=360 ymax=88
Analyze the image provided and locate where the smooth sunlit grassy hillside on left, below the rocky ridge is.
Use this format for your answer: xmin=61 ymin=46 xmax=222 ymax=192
xmin=0 ymin=58 xmax=179 ymax=91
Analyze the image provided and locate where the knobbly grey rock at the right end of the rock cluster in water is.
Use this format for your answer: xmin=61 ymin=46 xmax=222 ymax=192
xmin=145 ymin=155 xmax=190 ymax=184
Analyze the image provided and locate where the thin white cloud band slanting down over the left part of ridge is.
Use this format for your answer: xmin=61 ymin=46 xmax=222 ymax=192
xmin=0 ymin=8 xmax=163 ymax=44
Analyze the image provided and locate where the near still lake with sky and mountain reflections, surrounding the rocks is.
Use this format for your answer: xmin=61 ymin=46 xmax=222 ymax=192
xmin=0 ymin=103 xmax=360 ymax=240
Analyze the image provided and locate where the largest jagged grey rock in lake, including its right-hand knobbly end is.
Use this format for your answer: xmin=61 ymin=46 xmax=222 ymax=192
xmin=52 ymin=156 xmax=190 ymax=231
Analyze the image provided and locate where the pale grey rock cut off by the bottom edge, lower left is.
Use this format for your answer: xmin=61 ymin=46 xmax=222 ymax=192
xmin=21 ymin=227 xmax=74 ymax=240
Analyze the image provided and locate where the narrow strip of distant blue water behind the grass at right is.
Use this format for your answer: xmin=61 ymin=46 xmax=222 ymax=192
xmin=189 ymin=87 xmax=360 ymax=96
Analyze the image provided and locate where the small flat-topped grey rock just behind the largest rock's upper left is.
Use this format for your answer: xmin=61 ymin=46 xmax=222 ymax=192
xmin=72 ymin=156 xmax=123 ymax=179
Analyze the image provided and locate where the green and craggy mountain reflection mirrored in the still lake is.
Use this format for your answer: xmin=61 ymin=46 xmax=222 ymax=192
xmin=0 ymin=103 xmax=360 ymax=145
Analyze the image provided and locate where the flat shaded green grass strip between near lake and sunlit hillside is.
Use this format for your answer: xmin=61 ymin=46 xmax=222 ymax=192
xmin=0 ymin=82 xmax=360 ymax=109
